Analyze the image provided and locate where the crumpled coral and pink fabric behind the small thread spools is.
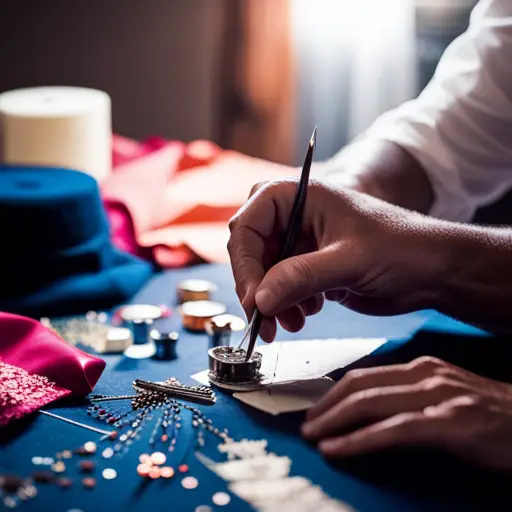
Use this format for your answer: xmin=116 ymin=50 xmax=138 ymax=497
xmin=101 ymin=136 xmax=298 ymax=268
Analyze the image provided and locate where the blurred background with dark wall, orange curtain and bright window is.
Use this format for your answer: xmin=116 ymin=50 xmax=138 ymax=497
xmin=0 ymin=0 xmax=476 ymax=165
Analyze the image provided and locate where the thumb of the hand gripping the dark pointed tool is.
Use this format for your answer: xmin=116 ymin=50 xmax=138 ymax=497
xmin=255 ymin=248 xmax=345 ymax=316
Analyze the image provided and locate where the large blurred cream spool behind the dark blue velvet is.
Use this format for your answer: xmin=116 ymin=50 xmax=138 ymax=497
xmin=0 ymin=87 xmax=112 ymax=181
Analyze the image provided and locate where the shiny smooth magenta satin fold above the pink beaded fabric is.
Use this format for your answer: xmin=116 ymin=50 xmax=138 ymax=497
xmin=0 ymin=312 xmax=105 ymax=395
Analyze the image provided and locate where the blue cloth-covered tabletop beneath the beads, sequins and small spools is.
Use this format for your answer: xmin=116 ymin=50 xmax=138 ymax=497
xmin=0 ymin=265 xmax=510 ymax=512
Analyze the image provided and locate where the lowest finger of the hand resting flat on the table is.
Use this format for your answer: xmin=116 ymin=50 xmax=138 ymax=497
xmin=318 ymin=412 xmax=450 ymax=458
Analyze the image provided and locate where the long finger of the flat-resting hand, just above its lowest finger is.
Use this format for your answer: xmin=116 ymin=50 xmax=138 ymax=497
xmin=302 ymin=377 xmax=465 ymax=439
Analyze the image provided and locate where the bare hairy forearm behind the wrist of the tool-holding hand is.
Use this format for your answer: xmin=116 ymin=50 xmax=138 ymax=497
xmin=435 ymin=223 xmax=512 ymax=333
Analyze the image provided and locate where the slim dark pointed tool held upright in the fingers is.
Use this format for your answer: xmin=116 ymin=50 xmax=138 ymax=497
xmin=242 ymin=126 xmax=316 ymax=362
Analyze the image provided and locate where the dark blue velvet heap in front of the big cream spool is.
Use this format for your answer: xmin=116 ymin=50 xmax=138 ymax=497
xmin=0 ymin=166 xmax=152 ymax=317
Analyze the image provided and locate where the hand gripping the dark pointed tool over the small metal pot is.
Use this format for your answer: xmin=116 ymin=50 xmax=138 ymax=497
xmin=228 ymin=179 xmax=443 ymax=341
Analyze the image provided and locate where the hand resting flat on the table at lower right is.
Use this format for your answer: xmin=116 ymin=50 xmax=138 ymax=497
xmin=302 ymin=357 xmax=512 ymax=469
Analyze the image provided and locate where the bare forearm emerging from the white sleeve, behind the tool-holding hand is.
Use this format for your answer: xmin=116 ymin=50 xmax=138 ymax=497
xmin=320 ymin=139 xmax=434 ymax=213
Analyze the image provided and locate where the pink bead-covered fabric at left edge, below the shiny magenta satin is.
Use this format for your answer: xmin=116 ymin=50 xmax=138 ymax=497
xmin=0 ymin=360 xmax=71 ymax=426
